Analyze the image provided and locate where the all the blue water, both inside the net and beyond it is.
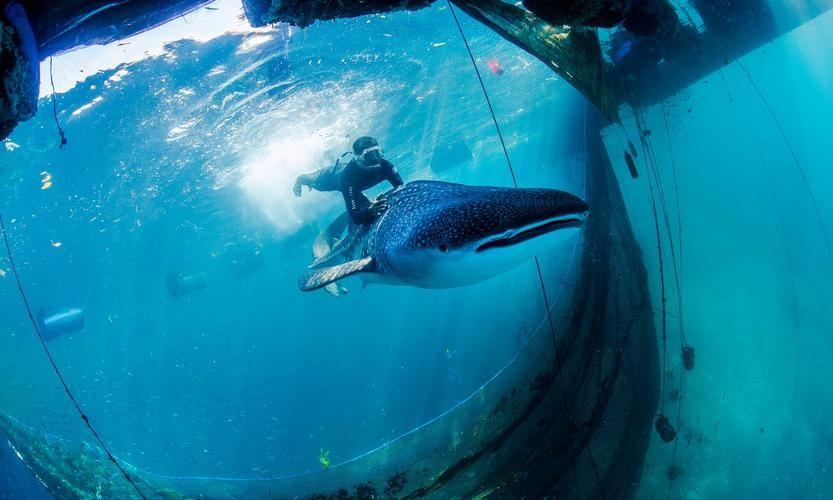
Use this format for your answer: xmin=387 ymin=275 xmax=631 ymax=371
xmin=0 ymin=3 xmax=833 ymax=498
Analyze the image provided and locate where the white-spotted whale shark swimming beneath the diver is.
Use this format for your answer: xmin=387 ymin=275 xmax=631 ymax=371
xmin=298 ymin=181 xmax=589 ymax=292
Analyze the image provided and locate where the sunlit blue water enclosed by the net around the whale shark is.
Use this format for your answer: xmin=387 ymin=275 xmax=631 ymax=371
xmin=3 ymin=0 xmax=584 ymax=492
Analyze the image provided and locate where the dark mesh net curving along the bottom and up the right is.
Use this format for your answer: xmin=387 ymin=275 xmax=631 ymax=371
xmin=0 ymin=102 xmax=658 ymax=498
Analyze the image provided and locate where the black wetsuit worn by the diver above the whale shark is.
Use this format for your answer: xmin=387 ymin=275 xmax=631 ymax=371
xmin=308 ymin=158 xmax=404 ymax=224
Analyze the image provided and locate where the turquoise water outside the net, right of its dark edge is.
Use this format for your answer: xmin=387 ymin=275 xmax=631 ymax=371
xmin=607 ymin=9 xmax=833 ymax=498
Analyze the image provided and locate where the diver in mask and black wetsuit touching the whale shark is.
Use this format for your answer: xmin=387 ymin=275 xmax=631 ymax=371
xmin=292 ymin=137 xmax=404 ymax=224
